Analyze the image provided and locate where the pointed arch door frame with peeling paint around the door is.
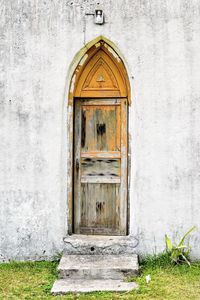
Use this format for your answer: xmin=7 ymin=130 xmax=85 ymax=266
xmin=65 ymin=36 xmax=131 ymax=234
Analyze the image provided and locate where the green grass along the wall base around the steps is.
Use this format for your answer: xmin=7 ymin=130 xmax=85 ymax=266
xmin=0 ymin=255 xmax=200 ymax=300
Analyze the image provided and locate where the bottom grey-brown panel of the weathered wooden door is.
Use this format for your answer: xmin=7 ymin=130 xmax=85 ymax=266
xmin=79 ymin=183 xmax=120 ymax=234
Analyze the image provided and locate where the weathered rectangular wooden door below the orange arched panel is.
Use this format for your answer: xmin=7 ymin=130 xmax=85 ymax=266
xmin=74 ymin=98 xmax=127 ymax=235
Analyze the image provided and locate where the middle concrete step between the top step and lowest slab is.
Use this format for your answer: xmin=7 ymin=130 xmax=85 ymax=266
xmin=58 ymin=254 xmax=139 ymax=279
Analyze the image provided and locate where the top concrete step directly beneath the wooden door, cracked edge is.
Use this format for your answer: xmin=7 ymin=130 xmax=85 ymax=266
xmin=64 ymin=234 xmax=138 ymax=255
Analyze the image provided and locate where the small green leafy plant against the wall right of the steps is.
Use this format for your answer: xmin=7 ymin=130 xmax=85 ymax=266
xmin=165 ymin=226 xmax=196 ymax=266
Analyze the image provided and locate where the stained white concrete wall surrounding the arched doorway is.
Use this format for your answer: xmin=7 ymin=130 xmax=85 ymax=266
xmin=0 ymin=0 xmax=200 ymax=260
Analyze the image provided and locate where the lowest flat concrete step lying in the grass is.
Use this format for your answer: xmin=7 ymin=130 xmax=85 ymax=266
xmin=51 ymin=279 xmax=137 ymax=295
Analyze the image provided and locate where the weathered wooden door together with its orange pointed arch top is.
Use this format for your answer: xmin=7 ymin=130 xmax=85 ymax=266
xmin=73 ymin=42 xmax=128 ymax=235
